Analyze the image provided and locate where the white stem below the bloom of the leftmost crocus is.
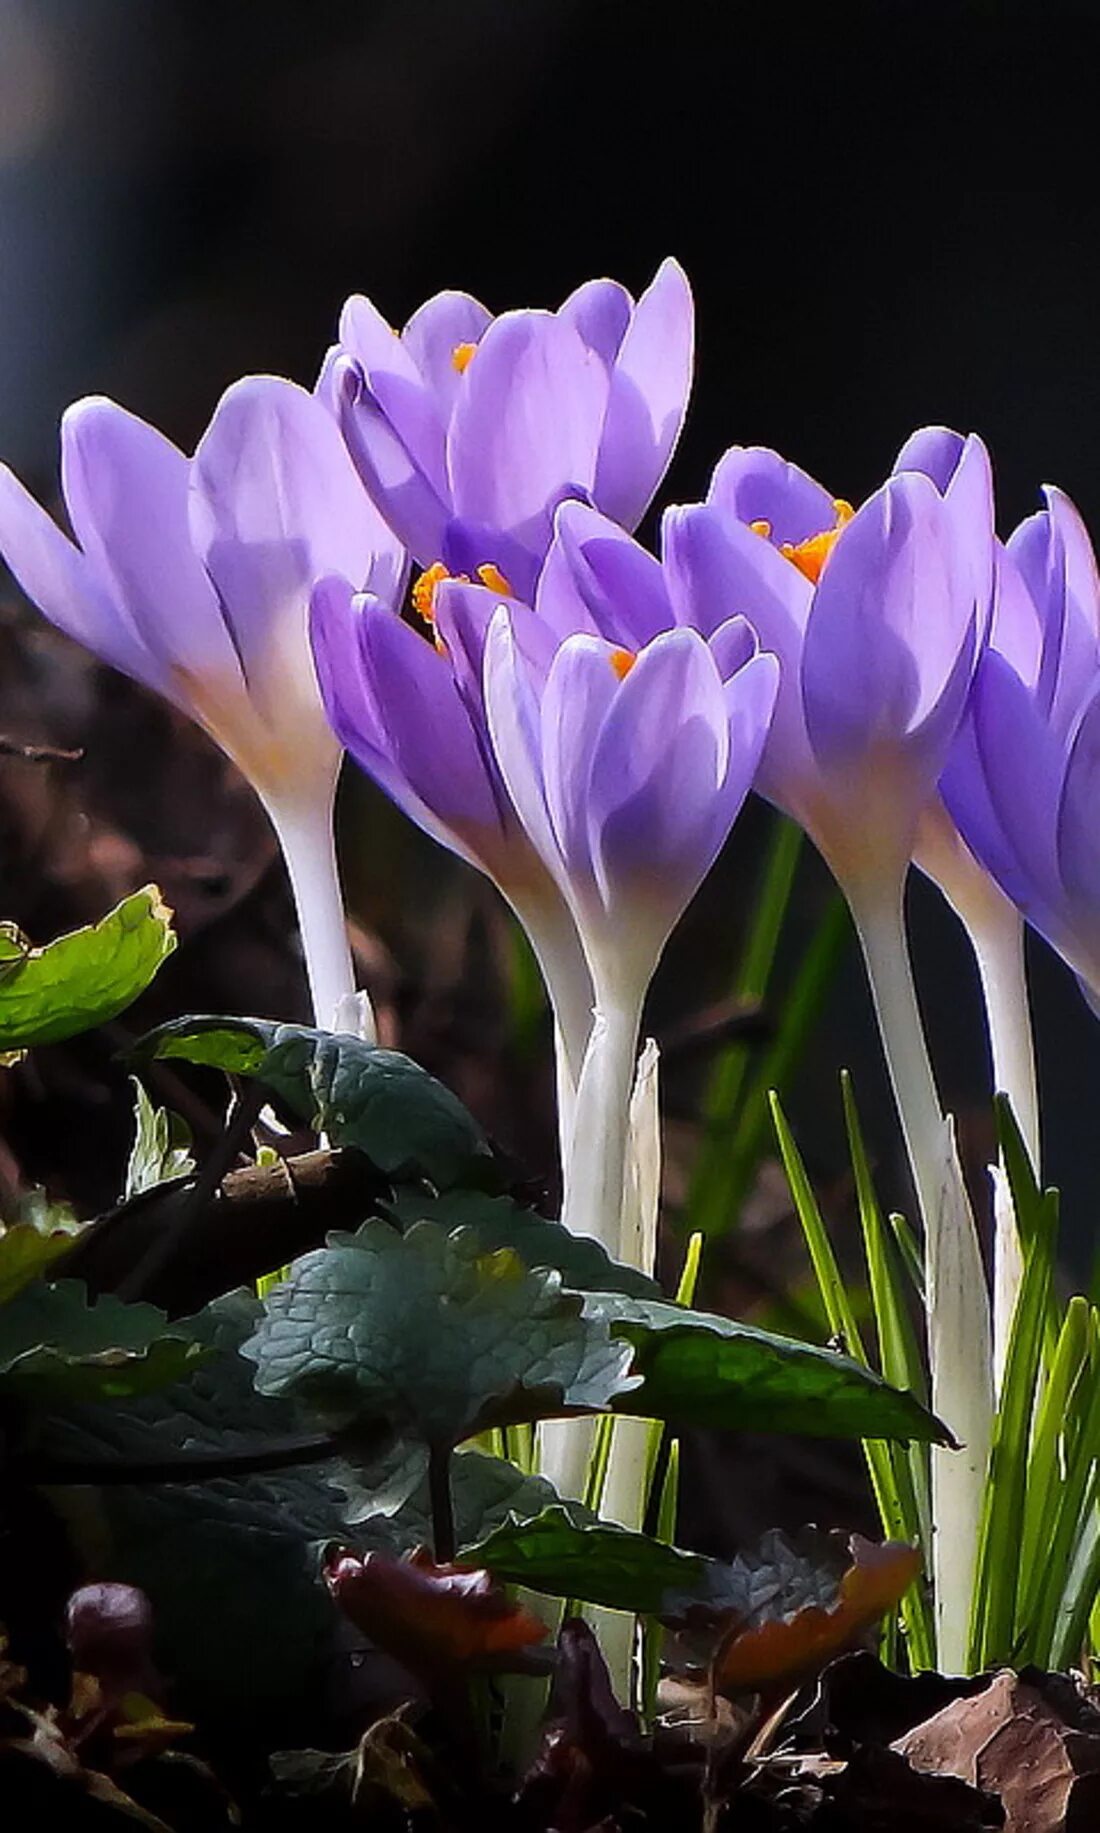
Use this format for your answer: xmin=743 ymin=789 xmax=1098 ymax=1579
xmin=266 ymin=790 xmax=366 ymax=1041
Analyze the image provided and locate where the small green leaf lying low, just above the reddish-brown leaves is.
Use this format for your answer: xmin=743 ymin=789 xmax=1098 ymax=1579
xmin=462 ymin=1503 xmax=708 ymax=1613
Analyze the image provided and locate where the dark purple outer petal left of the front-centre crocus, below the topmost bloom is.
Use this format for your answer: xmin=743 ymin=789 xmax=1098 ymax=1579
xmin=310 ymin=579 xmax=501 ymax=865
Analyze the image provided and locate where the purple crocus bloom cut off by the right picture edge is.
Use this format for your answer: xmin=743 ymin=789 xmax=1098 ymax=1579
xmin=942 ymin=472 xmax=1100 ymax=1003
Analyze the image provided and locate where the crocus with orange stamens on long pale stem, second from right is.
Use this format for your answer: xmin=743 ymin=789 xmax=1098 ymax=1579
xmin=700 ymin=434 xmax=994 ymax=1670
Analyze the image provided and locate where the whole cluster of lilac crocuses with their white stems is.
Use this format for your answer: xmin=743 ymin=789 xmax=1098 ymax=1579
xmin=0 ymin=262 xmax=1100 ymax=1666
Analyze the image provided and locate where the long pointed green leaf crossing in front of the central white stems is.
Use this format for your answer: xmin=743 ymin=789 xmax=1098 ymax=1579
xmin=585 ymin=1292 xmax=950 ymax=1444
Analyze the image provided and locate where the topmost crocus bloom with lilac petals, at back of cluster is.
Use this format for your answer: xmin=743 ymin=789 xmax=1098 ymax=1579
xmin=319 ymin=260 xmax=693 ymax=601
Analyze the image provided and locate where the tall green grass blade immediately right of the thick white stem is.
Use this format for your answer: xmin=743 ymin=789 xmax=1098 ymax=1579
xmin=970 ymin=1199 xmax=1058 ymax=1672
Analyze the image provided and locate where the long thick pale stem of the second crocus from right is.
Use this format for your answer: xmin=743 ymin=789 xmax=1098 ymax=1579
xmin=845 ymin=874 xmax=994 ymax=1674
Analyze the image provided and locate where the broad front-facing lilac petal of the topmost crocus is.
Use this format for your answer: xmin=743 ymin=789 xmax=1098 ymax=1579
xmin=447 ymin=312 xmax=607 ymax=557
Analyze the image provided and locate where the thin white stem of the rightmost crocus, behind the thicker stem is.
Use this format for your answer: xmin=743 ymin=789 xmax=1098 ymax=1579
xmin=915 ymin=801 xmax=1040 ymax=1393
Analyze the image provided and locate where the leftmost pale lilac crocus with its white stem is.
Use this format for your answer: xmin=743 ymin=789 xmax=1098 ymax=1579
xmin=0 ymin=376 xmax=405 ymax=1025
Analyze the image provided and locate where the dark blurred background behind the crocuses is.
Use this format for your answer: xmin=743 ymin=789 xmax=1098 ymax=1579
xmin=0 ymin=0 xmax=1100 ymax=1540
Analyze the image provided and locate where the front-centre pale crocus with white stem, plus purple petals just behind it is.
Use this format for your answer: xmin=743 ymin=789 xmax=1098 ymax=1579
xmin=484 ymin=504 xmax=777 ymax=1252
